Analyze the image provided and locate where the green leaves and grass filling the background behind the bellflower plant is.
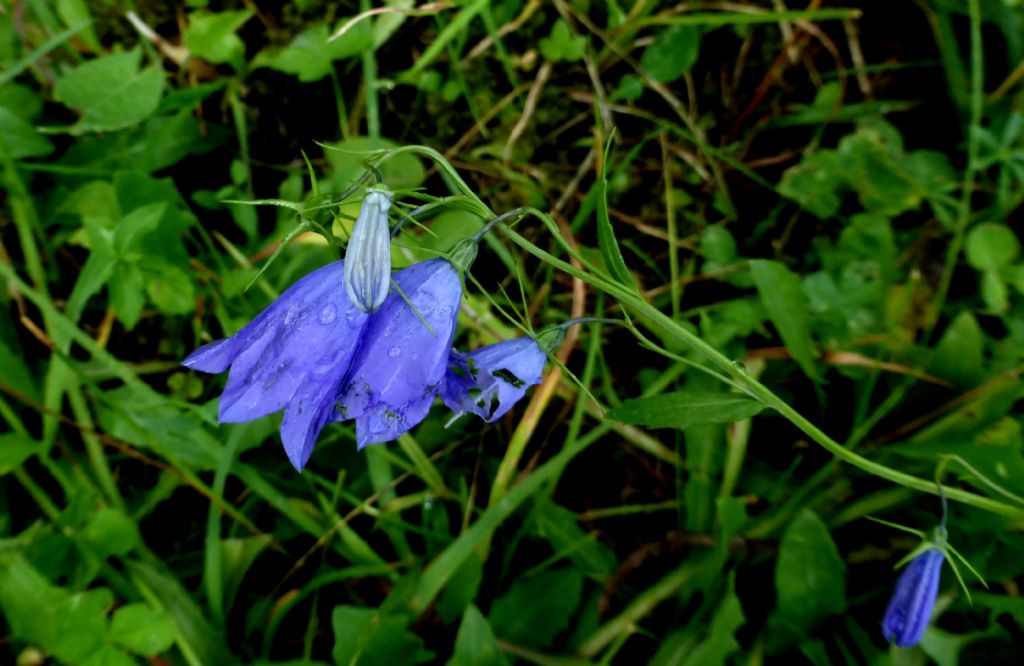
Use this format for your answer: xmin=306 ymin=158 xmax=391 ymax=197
xmin=0 ymin=0 xmax=1024 ymax=666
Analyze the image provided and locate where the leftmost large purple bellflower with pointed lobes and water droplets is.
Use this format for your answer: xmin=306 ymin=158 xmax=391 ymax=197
xmin=182 ymin=261 xmax=368 ymax=469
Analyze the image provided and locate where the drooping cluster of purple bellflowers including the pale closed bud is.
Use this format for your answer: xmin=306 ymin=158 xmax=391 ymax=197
xmin=182 ymin=204 xmax=540 ymax=470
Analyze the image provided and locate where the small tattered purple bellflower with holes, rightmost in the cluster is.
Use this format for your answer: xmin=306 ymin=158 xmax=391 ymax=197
xmin=441 ymin=337 xmax=548 ymax=422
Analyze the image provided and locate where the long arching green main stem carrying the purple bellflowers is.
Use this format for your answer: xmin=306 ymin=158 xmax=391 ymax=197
xmin=380 ymin=143 xmax=1024 ymax=521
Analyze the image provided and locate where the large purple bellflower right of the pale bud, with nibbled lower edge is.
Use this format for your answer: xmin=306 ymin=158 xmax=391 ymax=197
xmin=334 ymin=259 xmax=462 ymax=449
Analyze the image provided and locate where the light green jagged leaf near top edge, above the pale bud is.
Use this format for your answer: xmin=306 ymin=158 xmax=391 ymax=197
xmin=252 ymin=20 xmax=373 ymax=83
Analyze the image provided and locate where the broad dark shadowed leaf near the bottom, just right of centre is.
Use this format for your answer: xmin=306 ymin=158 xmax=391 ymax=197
xmin=489 ymin=569 xmax=583 ymax=649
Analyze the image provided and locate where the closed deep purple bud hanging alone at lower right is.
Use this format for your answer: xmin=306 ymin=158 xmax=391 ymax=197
xmin=882 ymin=548 xmax=946 ymax=648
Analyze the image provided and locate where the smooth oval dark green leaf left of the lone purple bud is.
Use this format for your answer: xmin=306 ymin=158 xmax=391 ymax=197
xmin=775 ymin=509 xmax=846 ymax=634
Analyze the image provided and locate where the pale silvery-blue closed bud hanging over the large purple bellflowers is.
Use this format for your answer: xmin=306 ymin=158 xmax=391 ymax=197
xmin=344 ymin=190 xmax=391 ymax=313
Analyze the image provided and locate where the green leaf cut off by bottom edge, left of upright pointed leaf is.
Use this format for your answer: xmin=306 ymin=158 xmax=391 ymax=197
xmin=331 ymin=606 xmax=432 ymax=666
